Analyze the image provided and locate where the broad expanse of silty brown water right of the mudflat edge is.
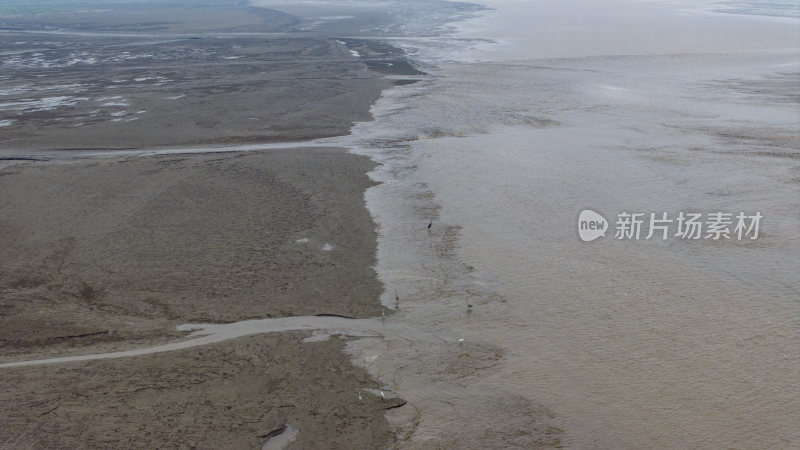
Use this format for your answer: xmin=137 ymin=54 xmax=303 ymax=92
xmin=332 ymin=2 xmax=800 ymax=448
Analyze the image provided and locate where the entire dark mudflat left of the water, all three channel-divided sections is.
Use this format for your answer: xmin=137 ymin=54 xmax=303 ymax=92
xmin=0 ymin=1 xmax=440 ymax=448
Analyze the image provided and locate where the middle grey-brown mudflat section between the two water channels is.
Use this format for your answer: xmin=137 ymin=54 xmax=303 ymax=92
xmin=0 ymin=149 xmax=381 ymax=358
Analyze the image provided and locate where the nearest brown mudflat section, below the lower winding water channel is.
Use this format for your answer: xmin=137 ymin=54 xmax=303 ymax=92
xmin=0 ymin=332 xmax=403 ymax=448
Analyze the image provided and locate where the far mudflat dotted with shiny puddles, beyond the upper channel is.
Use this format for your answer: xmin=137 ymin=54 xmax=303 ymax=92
xmin=0 ymin=2 xmax=432 ymax=151
